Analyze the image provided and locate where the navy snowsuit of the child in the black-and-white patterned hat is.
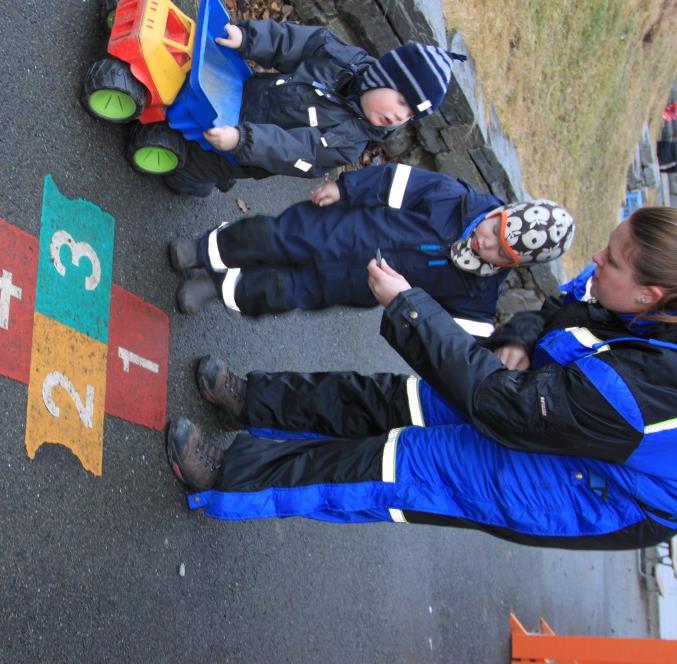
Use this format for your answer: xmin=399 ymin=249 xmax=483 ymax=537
xmin=200 ymin=164 xmax=508 ymax=323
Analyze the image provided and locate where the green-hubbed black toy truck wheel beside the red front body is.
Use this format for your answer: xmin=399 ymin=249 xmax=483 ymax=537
xmin=80 ymin=57 xmax=149 ymax=124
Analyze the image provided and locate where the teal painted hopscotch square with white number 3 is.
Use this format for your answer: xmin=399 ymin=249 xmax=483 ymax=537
xmin=35 ymin=175 xmax=115 ymax=343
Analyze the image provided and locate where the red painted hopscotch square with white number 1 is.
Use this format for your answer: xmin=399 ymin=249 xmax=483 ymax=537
xmin=106 ymin=284 xmax=169 ymax=431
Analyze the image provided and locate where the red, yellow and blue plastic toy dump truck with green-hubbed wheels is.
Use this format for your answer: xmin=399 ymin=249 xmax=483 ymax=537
xmin=81 ymin=0 xmax=251 ymax=175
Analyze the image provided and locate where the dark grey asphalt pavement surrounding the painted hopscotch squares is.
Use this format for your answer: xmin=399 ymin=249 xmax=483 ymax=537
xmin=0 ymin=0 xmax=648 ymax=664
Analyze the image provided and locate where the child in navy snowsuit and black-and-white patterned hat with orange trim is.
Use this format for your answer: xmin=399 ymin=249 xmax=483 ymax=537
xmin=170 ymin=164 xmax=574 ymax=330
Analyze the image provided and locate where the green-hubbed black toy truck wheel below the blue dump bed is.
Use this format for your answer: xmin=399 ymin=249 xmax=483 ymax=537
xmin=127 ymin=122 xmax=188 ymax=175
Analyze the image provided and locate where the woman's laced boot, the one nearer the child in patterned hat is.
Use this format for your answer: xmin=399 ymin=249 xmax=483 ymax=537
xmin=196 ymin=355 xmax=247 ymax=431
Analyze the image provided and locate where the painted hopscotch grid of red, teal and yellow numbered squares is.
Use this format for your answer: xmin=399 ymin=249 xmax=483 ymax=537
xmin=0 ymin=176 xmax=169 ymax=476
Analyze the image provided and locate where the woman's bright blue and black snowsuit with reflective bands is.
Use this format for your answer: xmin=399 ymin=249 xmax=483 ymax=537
xmin=190 ymin=289 xmax=677 ymax=549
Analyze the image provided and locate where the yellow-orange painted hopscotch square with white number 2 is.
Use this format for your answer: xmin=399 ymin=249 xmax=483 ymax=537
xmin=26 ymin=312 xmax=107 ymax=477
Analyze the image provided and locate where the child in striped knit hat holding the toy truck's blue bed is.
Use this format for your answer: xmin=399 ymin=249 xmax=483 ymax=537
xmin=165 ymin=21 xmax=465 ymax=196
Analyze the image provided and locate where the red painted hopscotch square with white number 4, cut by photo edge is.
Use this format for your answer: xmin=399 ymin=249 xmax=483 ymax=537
xmin=0 ymin=219 xmax=38 ymax=383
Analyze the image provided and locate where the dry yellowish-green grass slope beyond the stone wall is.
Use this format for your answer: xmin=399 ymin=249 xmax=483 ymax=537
xmin=444 ymin=0 xmax=677 ymax=273
